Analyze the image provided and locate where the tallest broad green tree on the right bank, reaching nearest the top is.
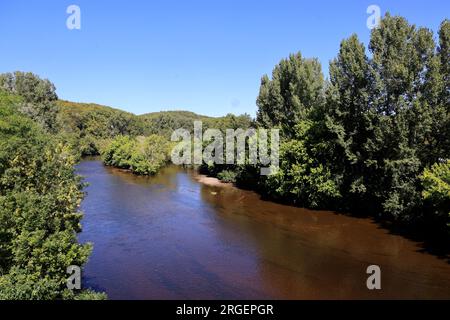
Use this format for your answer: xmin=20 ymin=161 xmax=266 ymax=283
xmin=369 ymin=14 xmax=442 ymax=220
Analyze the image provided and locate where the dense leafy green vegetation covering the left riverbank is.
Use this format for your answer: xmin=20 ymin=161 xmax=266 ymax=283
xmin=0 ymin=87 xmax=104 ymax=299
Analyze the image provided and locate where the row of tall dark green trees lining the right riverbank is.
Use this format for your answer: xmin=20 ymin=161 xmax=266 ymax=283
xmin=203 ymin=14 xmax=450 ymax=232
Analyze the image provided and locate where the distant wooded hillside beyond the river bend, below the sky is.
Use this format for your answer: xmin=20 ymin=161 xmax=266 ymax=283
xmin=56 ymin=100 xmax=253 ymax=156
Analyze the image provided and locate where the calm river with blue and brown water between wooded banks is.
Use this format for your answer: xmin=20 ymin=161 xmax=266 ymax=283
xmin=78 ymin=160 xmax=450 ymax=299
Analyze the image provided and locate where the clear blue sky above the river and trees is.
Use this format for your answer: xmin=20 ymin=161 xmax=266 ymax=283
xmin=0 ymin=0 xmax=450 ymax=116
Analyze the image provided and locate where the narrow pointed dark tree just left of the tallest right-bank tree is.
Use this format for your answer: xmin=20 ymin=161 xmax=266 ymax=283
xmin=320 ymin=35 xmax=377 ymax=208
